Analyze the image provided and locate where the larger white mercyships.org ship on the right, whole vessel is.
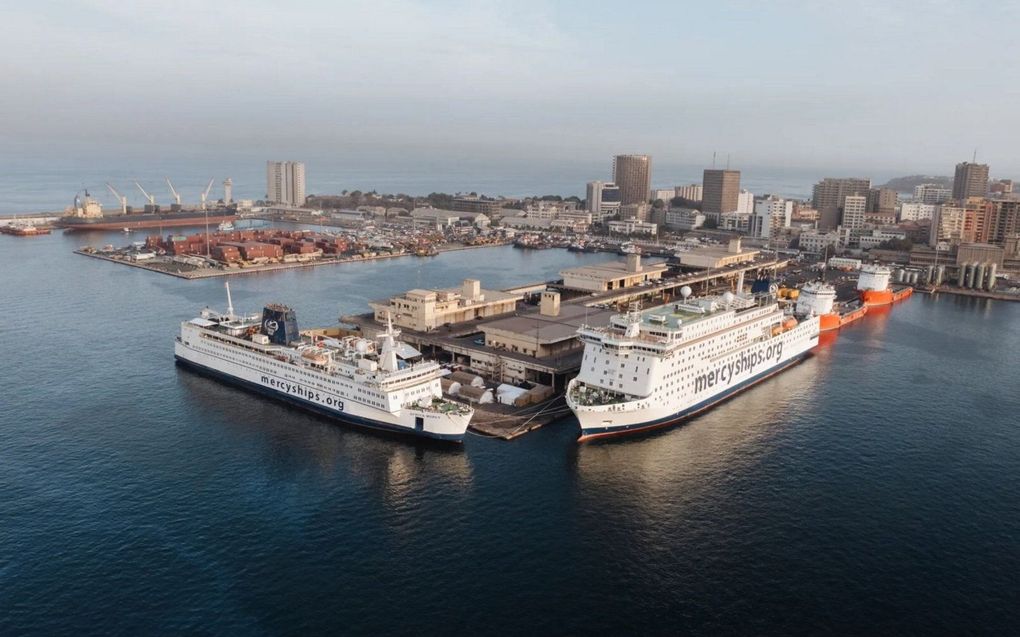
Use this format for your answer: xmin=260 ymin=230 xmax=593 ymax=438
xmin=566 ymin=287 xmax=819 ymax=440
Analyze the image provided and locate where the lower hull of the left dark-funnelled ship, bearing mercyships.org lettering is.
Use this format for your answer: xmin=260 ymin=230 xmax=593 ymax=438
xmin=174 ymin=340 xmax=469 ymax=443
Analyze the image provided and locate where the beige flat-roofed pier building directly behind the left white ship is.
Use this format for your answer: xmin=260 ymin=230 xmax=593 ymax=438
xmin=368 ymin=278 xmax=523 ymax=331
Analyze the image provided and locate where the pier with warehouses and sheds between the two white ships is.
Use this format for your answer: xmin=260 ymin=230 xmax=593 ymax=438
xmin=341 ymin=248 xmax=787 ymax=439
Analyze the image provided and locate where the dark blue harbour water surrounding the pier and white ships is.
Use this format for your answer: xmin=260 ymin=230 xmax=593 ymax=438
xmin=0 ymin=232 xmax=1020 ymax=636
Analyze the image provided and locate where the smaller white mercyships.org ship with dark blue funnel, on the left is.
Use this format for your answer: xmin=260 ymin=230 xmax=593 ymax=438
xmin=173 ymin=286 xmax=473 ymax=442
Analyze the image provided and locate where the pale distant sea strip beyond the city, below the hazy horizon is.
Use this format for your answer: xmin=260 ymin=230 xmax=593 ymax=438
xmin=0 ymin=152 xmax=836 ymax=216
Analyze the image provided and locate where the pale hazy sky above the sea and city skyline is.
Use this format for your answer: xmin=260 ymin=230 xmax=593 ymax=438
xmin=0 ymin=0 xmax=1020 ymax=176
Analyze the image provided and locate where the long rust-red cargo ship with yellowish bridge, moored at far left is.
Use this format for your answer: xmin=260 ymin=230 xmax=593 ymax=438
xmin=56 ymin=191 xmax=238 ymax=231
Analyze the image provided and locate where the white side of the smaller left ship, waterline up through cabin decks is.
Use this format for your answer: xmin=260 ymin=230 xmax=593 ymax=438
xmin=173 ymin=332 xmax=470 ymax=442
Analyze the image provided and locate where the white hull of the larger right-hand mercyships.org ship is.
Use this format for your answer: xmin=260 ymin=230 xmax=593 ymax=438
xmin=566 ymin=297 xmax=819 ymax=441
